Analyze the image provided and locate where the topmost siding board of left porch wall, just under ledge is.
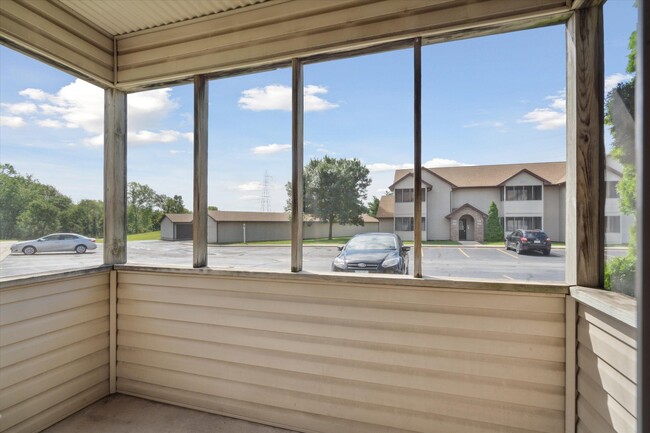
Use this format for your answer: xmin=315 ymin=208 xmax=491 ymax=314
xmin=0 ymin=273 xmax=108 ymax=305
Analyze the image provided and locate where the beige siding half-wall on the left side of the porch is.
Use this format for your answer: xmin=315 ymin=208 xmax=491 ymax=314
xmin=0 ymin=271 xmax=109 ymax=432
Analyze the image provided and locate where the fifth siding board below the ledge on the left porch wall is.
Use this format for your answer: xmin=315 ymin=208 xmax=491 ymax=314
xmin=0 ymin=334 xmax=108 ymax=390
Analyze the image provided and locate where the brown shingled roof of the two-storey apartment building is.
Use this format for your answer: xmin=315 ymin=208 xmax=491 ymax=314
xmin=394 ymin=161 xmax=566 ymax=188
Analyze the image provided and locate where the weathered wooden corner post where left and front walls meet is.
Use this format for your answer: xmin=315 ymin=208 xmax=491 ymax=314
xmin=104 ymin=89 xmax=127 ymax=265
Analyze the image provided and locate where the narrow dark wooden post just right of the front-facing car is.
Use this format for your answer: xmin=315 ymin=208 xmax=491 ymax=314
xmin=413 ymin=38 xmax=422 ymax=278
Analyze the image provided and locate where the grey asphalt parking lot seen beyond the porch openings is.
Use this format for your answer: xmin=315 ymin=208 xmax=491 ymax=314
xmin=0 ymin=241 xmax=625 ymax=283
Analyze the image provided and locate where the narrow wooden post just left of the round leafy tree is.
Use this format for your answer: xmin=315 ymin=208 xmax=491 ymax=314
xmin=291 ymin=59 xmax=304 ymax=272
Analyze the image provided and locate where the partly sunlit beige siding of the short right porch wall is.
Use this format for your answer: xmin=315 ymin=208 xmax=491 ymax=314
xmin=577 ymin=300 xmax=637 ymax=433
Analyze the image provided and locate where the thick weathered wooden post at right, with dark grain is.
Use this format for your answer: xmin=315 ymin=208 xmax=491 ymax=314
xmin=566 ymin=6 xmax=605 ymax=288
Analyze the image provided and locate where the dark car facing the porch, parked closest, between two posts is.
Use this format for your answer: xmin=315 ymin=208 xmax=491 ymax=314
xmin=332 ymin=233 xmax=411 ymax=274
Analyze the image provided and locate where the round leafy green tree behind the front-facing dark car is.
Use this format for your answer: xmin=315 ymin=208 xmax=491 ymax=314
xmin=286 ymin=155 xmax=370 ymax=239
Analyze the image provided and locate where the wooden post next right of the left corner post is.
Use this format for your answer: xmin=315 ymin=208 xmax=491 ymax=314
xmin=192 ymin=75 xmax=208 ymax=268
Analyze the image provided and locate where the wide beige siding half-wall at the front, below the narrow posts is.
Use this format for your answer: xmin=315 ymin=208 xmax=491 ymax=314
xmin=117 ymin=269 xmax=565 ymax=433
